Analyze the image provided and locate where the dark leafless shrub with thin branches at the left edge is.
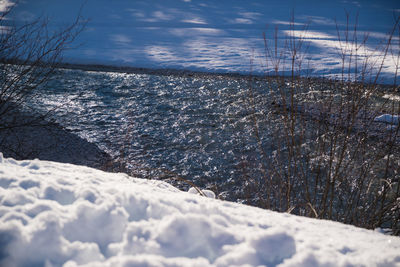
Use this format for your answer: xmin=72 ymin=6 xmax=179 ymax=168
xmin=0 ymin=3 xmax=86 ymax=158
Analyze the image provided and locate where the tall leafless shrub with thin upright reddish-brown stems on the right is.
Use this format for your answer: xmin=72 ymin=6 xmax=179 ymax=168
xmin=246 ymin=14 xmax=400 ymax=235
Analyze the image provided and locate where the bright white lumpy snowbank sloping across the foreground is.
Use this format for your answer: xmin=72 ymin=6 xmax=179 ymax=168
xmin=0 ymin=153 xmax=400 ymax=267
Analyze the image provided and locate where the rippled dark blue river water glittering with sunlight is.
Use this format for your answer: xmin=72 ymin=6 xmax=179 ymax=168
xmin=32 ymin=70 xmax=276 ymax=201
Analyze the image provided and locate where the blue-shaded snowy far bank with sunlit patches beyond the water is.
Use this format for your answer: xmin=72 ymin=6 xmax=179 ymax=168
xmin=1 ymin=0 xmax=400 ymax=82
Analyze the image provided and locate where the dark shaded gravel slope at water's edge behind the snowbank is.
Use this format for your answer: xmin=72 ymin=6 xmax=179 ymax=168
xmin=0 ymin=107 xmax=112 ymax=170
